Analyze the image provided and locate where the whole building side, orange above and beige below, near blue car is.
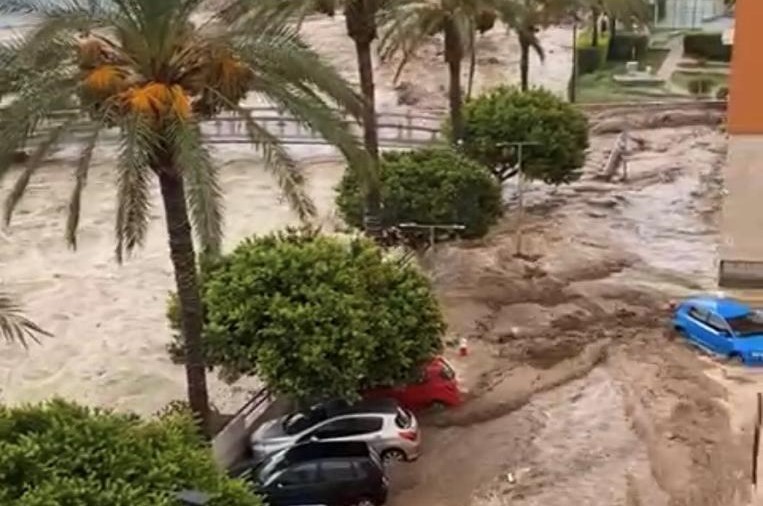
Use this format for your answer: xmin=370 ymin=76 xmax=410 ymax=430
xmin=719 ymin=0 xmax=763 ymax=289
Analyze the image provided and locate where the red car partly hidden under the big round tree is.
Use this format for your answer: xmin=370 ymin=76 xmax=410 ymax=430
xmin=364 ymin=357 xmax=461 ymax=410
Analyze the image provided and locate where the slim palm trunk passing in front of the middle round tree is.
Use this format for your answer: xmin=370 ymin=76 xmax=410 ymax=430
xmin=345 ymin=0 xmax=382 ymax=238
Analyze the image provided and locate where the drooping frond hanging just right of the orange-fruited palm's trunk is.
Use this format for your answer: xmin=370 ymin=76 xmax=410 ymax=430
xmin=168 ymin=116 xmax=223 ymax=254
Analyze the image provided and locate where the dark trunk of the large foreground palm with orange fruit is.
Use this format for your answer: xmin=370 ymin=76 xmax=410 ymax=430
xmin=156 ymin=169 xmax=211 ymax=436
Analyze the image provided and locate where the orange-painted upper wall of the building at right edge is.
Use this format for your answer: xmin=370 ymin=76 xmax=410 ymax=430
xmin=728 ymin=0 xmax=763 ymax=134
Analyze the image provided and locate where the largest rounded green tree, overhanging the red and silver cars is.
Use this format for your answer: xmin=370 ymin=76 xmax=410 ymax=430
xmin=174 ymin=230 xmax=445 ymax=400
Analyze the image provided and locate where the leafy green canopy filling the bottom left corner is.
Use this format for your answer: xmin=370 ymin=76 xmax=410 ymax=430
xmin=0 ymin=400 xmax=261 ymax=506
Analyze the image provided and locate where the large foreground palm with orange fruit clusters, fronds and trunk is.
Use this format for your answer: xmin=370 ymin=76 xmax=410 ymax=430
xmin=0 ymin=0 xmax=367 ymax=430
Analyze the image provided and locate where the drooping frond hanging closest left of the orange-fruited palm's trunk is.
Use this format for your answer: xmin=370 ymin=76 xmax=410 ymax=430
xmin=115 ymin=114 xmax=157 ymax=263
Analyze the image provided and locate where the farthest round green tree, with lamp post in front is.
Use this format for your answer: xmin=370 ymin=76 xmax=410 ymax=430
xmin=462 ymin=86 xmax=588 ymax=184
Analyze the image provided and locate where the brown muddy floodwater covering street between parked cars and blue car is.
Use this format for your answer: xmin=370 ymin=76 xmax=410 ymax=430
xmin=391 ymin=127 xmax=749 ymax=506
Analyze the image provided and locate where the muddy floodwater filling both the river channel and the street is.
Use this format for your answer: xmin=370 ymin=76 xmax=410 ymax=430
xmin=0 ymin=12 xmax=752 ymax=506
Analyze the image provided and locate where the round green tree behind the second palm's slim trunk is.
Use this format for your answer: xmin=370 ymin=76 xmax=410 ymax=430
xmin=336 ymin=148 xmax=503 ymax=238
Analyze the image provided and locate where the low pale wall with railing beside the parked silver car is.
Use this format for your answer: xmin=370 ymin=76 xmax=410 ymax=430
xmin=212 ymin=388 xmax=273 ymax=469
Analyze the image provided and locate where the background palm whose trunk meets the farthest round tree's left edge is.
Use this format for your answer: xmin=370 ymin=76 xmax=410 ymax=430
xmin=380 ymin=0 xmax=502 ymax=143
